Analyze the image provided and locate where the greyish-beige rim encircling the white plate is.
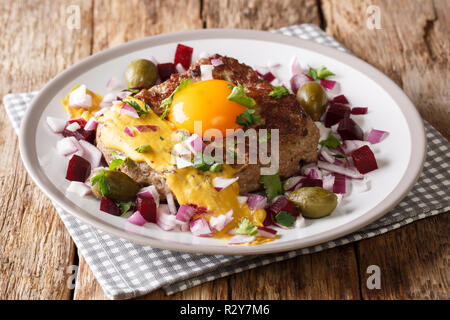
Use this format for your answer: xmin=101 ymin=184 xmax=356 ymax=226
xmin=19 ymin=29 xmax=426 ymax=255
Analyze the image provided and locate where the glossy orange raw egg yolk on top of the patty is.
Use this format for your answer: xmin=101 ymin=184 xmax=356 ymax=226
xmin=168 ymin=79 xmax=246 ymax=137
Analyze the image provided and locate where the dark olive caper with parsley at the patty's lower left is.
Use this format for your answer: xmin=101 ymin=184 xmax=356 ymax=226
xmin=91 ymin=170 xmax=140 ymax=202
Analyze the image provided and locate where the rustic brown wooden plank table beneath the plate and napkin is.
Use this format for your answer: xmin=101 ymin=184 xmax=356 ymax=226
xmin=0 ymin=0 xmax=450 ymax=299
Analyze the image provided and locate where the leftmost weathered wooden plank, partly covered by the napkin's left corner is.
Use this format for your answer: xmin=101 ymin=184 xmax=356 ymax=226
xmin=0 ymin=0 xmax=91 ymax=300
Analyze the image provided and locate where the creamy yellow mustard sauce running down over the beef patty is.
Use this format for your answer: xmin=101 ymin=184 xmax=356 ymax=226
xmin=63 ymin=88 xmax=273 ymax=245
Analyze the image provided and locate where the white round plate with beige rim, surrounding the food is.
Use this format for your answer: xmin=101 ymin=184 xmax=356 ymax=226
xmin=20 ymin=30 xmax=425 ymax=254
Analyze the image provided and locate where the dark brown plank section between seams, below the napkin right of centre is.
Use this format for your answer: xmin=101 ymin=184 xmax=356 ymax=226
xmin=229 ymin=244 xmax=360 ymax=300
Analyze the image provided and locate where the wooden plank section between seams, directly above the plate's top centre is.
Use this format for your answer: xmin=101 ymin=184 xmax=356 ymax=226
xmin=203 ymin=0 xmax=320 ymax=30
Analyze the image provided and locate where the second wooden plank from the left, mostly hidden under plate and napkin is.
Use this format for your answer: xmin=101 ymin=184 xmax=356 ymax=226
xmin=74 ymin=0 xmax=203 ymax=300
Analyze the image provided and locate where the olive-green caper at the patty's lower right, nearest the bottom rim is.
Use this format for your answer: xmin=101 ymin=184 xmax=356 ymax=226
xmin=289 ymin=187 xmax=337 ymax=219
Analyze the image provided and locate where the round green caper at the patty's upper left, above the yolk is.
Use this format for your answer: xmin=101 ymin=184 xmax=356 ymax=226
xmin=125 ymin=59 xmax=158 ymax=88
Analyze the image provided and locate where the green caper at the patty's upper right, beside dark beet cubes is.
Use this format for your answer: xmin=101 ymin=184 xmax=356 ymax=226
xmin=297 ymin=81 xmax=328 ymax=121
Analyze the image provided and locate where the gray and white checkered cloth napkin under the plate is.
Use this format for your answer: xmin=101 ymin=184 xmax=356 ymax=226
xmin=3 ymin=24 xmax=450 ymax=299
